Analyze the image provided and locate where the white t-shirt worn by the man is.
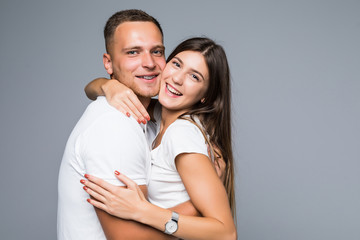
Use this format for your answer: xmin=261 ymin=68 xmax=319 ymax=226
xmin=57 ymin=97 xmax=150 ymax=240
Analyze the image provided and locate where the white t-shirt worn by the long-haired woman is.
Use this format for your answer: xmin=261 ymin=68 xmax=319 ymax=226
xmin=148 ymin=119 xmax=208 ymax=208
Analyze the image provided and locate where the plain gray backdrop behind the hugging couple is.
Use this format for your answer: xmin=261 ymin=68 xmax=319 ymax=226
xmin=0 ymin=0 xmax=360 ymax=240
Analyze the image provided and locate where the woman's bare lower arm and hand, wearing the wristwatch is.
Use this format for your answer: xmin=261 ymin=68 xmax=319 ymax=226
xmin=83 ymin=156 xmax=236 ymax=240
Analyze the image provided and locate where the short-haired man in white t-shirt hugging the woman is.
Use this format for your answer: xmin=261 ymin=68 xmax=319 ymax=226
xmin=58 ymin=10 xmax=191 ymax=240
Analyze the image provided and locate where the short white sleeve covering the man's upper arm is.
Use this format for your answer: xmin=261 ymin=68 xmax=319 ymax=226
xmin=80 ymin=112 xmax=149 ymax=186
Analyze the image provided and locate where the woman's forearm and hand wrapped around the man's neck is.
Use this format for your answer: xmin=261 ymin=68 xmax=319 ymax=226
xmin=84 ymin=78 xmax=150 ymax=123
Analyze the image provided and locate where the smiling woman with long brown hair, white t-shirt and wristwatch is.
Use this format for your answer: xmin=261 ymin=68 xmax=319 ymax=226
xmin=84 ymin=38 xmax=236 ymax=239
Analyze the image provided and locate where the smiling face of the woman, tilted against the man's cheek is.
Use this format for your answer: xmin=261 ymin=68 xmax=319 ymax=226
xmin=159 ymin=51 xmax=209 ymax=114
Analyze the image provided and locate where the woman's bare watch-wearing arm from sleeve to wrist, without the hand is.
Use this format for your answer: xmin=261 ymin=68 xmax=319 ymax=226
xmin=133 ymin=153 xmax=236 ymax=240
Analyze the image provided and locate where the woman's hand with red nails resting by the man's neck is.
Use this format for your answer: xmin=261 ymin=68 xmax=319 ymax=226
xmin=101 ymin=79 xmax=150 ymax=124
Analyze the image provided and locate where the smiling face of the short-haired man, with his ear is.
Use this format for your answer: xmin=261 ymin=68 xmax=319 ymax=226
xmin=103 ymin=22 xmax=166 ymax=97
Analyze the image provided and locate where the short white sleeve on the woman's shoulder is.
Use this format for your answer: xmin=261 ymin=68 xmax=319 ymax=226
xmin=162 ymin=119 xmax=208 ymax=170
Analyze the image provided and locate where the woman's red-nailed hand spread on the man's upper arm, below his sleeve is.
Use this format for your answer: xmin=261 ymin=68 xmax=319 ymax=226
xmin=80 ymin=171 xmax=148 ymax=220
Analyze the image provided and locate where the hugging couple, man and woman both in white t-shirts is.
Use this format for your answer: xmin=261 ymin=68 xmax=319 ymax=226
xmin=57 ymin=10 xmax=237 ymax=240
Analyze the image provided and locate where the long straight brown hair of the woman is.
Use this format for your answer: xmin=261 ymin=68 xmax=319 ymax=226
xmin=167 ymin=38 xmax=236 ymax=218
